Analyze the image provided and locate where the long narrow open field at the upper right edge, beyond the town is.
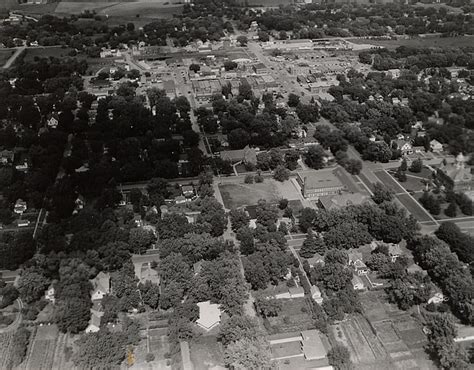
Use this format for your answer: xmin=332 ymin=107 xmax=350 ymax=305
xmin=350 ymin=36 xmax=474 ymax=49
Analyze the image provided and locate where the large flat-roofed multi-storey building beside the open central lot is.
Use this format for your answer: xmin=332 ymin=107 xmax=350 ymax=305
xmin=296 ymin=169 xmax=347 ymax=198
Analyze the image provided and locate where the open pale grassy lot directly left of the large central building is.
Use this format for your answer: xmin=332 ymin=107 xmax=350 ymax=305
xmin=219 ymin=178 xmax=300 ymax=209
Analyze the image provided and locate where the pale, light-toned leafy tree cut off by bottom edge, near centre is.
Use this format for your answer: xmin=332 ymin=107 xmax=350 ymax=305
xmin=224 ymin=338 xmax=272 ymax=369
